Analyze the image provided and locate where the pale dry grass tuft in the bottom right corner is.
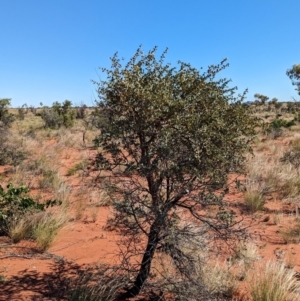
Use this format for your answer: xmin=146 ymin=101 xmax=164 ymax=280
xmin=248 ymin=262 xmax=300 ymax=301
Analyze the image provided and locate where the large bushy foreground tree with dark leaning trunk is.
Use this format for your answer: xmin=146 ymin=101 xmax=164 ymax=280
xmin=94 ymin=48 xmax=257 ymax=297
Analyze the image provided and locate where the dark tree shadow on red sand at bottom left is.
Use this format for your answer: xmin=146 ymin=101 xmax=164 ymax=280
xmin=0 ymin=255 xmax=124 ymax=301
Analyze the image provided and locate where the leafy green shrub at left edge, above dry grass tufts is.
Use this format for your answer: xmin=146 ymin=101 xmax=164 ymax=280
xmin=0 ymin=183 xmax=61 ymax=235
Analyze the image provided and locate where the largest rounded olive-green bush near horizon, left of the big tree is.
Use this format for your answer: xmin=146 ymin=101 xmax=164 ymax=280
xmin=41 ymin=100 xmax=76 ymax=129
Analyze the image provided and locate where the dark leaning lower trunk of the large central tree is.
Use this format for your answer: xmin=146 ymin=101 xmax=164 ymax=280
xmin=121 ymin=222 xmax=160 ymax=298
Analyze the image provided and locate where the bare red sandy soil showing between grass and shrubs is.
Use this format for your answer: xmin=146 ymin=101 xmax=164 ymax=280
xmin=0 ymin=114 xmax=300 ymax=301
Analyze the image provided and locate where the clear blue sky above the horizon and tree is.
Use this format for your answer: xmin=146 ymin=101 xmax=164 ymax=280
xmin=0 ymin=0 xmax=300 ymax=107
